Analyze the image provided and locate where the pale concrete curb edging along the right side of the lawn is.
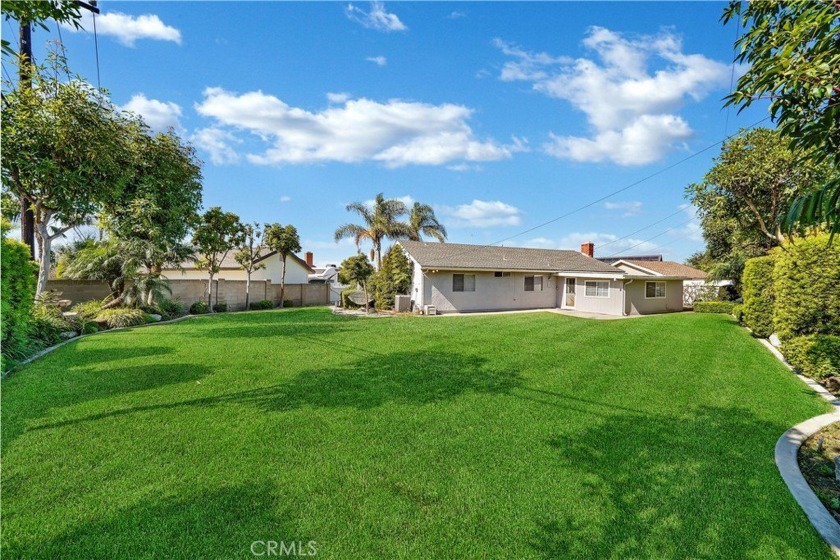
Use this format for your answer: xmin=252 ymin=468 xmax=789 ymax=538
xmin=758 ymin=338 xmax=840 ymax=557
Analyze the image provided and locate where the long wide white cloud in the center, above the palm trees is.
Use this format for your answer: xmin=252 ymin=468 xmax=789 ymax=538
xmin=196 ymin=88 xmax=524 ymax=167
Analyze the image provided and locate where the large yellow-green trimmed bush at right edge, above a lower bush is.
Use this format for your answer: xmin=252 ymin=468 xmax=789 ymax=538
xmin=773 ymin=235 xmax=840 ymax=340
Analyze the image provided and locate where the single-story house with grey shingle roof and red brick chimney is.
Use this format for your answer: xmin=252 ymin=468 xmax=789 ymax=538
xmin=399 ymin=241 xmax=687 ymax=316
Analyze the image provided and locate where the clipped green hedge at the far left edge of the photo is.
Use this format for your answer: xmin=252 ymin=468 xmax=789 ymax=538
xmin=0 ymin=225 xmax=35 ymax=371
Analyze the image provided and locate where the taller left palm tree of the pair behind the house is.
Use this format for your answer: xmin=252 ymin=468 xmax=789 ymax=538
xmin=335 ymin=193 xmax=411 ymax=270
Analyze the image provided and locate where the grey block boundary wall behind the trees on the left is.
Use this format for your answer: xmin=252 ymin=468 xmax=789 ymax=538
xmin=47 ymin=280 xmax=329 ymax=311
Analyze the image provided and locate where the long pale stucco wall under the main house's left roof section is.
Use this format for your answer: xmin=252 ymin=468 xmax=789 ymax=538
xmin=423 ymin=271 xmax=557 ymax=313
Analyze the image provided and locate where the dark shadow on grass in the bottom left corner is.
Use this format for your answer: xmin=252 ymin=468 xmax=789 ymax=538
xmin=3 ymin=484 xmax=302 ymax=560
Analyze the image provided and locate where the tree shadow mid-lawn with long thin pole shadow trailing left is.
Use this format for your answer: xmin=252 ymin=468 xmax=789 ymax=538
xmin=32 ymin=351 xmax=522 ymax=429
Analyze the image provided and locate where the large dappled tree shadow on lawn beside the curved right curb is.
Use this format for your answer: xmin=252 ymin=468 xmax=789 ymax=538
xmin=530 ymin=407 xmax=829 ymax=559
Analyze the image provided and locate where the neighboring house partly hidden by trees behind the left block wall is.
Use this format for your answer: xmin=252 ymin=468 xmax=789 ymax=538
xmin=163 ymin=251 xmax=315 ymax=284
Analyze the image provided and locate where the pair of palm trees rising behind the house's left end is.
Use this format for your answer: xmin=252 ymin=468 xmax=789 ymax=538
xmin=335 ymin=193 xmax=446 ymax=268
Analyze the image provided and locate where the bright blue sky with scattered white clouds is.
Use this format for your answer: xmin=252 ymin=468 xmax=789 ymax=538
xmin=8 ymin=0 xmax=766 ymax=264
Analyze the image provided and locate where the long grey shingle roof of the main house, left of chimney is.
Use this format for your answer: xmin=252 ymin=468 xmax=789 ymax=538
xmin=399 ymin=241 xmax=623 ymax=275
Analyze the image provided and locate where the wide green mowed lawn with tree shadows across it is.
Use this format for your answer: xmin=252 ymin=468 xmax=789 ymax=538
xmin=2 ymin=309 xmax=831 ymax=560
